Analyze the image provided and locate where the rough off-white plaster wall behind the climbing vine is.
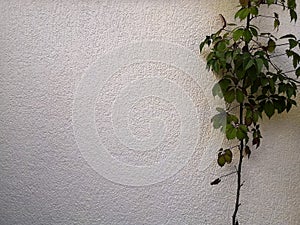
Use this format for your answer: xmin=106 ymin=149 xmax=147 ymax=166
xmin=0 ymin=0 xmax=300 ymax=225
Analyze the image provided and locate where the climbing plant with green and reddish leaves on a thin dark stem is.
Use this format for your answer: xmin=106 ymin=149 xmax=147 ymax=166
xmin=200 ymin=0 xmax=300 ymax=225
